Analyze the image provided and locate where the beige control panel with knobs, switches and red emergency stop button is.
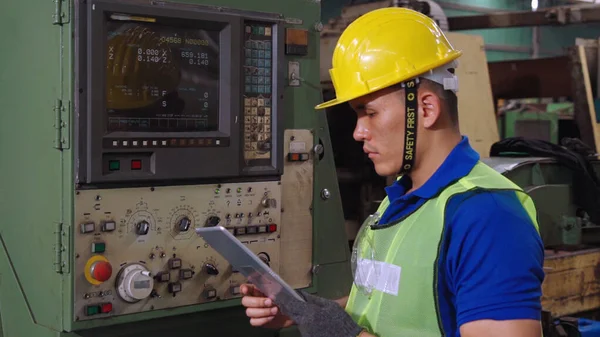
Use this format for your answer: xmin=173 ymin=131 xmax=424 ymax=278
xmin=74 ymin=181 xmax=281 ymax=320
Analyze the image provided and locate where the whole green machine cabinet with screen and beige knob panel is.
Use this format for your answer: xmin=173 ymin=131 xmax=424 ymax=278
xmin=0 ymin=0 xmax=351 ymax=337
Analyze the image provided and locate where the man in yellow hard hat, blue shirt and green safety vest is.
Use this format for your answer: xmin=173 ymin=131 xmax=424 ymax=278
xmin=242 ymin=8 xmax=544 ymax=337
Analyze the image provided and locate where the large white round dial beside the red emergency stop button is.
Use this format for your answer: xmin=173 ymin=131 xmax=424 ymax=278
xmin=117 ymin=263 xmax=154 ymax=303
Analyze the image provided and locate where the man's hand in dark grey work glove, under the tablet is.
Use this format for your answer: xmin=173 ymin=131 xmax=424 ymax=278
xmin=276 ymin=292 xmax=363 ymax=337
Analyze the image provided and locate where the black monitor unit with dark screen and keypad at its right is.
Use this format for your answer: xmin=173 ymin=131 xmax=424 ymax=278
xmin=75 ymin=0 xmax=285 ymax=185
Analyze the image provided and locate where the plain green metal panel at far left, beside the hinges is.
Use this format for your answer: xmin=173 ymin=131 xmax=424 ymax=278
xmin=0 ymin=1 xmax=69 ymax=330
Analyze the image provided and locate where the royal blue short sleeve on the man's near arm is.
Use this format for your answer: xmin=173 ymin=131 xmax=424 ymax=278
xmin=445 ymin=191 xmax=544 ymax=327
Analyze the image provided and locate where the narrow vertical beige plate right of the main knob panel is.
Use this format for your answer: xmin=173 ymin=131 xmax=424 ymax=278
xmin=279 ymin=130 xmax=314 ymax=288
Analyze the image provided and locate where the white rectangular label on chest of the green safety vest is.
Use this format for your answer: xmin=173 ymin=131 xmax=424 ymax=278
xmin=354 ymin=259 xmax=402 ymax=296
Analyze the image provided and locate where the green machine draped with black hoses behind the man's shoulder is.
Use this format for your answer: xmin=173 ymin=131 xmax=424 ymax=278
xmin=483 ymin=156 xmax=600 ymax=250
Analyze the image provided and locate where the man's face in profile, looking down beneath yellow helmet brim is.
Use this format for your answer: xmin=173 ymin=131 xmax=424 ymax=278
xmin=350 ymin=89 xmax=405 ymax=176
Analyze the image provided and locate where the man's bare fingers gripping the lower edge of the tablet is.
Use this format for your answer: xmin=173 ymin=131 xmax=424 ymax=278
xmin=240 ymin=284 xmax=294 ymax=329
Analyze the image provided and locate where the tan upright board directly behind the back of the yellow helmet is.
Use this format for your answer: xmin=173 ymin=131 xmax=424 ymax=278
xmin=446 ymin=32 xmax=500 ymax=158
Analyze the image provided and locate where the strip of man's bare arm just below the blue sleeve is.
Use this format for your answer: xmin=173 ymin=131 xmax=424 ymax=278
xmin=460 ymin=319 xmax=542 ymax=337
